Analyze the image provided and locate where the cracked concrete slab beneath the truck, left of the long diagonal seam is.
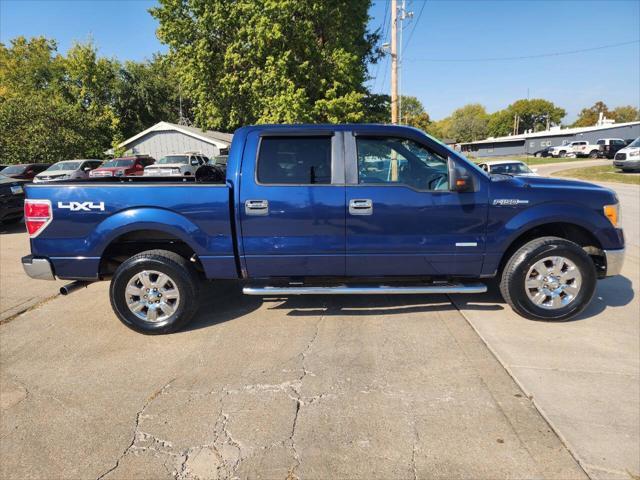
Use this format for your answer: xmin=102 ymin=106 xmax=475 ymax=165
xmin=0 ymin=276 xmax=586 ymax=480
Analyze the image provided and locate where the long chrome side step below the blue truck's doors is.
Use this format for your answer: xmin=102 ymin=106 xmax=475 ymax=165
xmin=242 ymin=283 xmax=487 ymax=296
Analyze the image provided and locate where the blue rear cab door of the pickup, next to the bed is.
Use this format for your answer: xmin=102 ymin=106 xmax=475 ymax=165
xmin=238 ymin=128 xmax=345 ymax=278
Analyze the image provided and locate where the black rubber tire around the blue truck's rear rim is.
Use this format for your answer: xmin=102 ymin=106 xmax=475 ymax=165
xmin=109 ymin=250 xmax=200 ymax=335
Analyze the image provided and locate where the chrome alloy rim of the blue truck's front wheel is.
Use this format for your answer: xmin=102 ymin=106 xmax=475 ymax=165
xmin=525 ymin=257 xmax=582 ymax=310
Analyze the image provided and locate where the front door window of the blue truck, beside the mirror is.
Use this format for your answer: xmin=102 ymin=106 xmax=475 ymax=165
xmin=356 ymin=137 xmax=449 ymax=190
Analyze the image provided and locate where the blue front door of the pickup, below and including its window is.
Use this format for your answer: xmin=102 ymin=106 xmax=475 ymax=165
xmin=345 ymin=131 xmax=488 ymax=276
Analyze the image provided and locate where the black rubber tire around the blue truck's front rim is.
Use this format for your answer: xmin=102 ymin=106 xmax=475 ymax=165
xmin=500 ymin=237 xmax=597 ymax=321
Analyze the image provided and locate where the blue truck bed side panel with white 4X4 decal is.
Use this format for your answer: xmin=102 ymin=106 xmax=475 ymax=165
xmin=26 ymin=181 xmax=237 ymax=279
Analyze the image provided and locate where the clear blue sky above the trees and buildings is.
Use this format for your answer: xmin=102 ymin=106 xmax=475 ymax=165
xmin=0 ymin=0 xmax=640 ymax=123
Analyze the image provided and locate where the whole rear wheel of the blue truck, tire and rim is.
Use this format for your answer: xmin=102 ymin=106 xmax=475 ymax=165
xmin=109 ymin=250 xmax=199 ymax=335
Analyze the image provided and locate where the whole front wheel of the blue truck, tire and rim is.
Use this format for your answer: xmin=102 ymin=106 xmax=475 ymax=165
xmin=500 ymin=237 xmax=597 ymax=321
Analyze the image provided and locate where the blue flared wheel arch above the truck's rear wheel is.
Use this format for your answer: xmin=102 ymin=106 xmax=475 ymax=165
xmin=86 ymin=207 xmax=207 ymax=257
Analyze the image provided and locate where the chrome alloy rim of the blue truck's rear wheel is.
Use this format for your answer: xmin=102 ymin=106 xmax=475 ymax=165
xmin=125 ymin=270 xmax=180 ymax=322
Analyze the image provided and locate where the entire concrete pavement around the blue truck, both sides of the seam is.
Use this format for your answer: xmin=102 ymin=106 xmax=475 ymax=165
xmin=0 ymin=166 xmax=640 ymax=479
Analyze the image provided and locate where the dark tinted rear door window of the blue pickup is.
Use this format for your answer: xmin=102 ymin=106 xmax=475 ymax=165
xmin=258 ymin=137 xmax=331 ymax=185
